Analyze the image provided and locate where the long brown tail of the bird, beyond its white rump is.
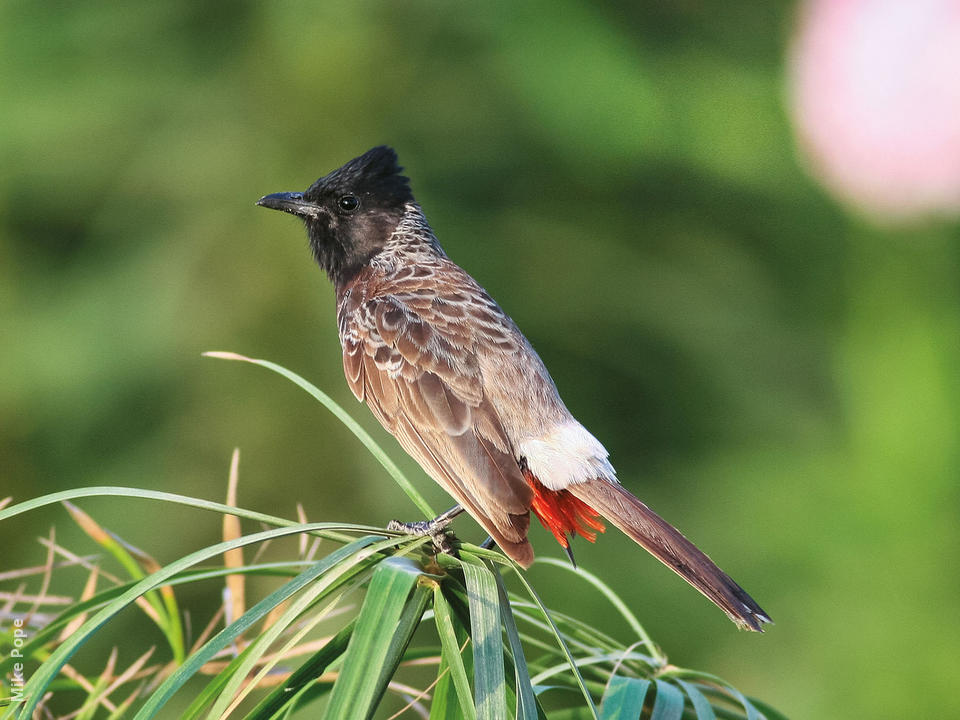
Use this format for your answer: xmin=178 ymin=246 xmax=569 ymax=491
xmin=567 ymin=480 xmax=771 ymax=632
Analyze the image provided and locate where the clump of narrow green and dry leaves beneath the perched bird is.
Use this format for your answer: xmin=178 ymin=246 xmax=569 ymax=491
xmin=0 ymin=361 xmax=777 ymax=720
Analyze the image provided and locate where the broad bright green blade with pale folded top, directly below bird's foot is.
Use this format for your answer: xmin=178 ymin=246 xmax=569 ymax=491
xmin=325 ymin=558 xmax=423 ymax=720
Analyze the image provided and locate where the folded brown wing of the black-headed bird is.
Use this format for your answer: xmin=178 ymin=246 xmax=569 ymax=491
xmin=339 ymin=278 xmax=533 ymax=566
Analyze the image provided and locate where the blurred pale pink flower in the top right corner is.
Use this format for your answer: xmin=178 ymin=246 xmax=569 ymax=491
xmin=790 ymin=0 xmax=960 ymax=218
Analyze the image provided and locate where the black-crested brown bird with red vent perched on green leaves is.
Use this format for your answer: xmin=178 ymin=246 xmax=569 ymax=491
xmin=257 ymin=145 xmax=771 ymax=632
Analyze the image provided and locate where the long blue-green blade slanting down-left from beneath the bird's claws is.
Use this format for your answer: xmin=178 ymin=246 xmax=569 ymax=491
xmin=135 ymin=530 xmax=396 ymax=720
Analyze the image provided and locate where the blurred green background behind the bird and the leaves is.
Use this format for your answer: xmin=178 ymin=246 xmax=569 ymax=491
xmin=0 ymin=0 xmax=960 ymax=718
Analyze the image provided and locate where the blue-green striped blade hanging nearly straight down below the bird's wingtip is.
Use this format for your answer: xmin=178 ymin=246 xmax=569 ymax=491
xmin=460 ymin=552 xmax=507 ymax=720
